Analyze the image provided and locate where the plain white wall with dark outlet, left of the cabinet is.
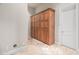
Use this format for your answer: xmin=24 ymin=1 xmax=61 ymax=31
xmin=0 ymin=3 xmax=29 ymax=54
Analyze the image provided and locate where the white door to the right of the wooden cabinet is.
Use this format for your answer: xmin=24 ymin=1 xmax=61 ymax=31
xmin=59 ymin=5 xmax=76 ymax=49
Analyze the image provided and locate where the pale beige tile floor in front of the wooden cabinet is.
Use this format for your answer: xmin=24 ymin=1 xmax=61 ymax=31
xmin=16 ymin=39 xmax=75 ymax=55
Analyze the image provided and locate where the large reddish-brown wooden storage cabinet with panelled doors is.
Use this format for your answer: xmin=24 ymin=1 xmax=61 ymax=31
xmin=31 ymin=8 xmax=55 ymax=45
